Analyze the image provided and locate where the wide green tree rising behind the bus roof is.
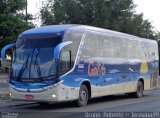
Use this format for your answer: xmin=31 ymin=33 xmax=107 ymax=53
xmin=41 ymin=0 xmax=157 ymax=39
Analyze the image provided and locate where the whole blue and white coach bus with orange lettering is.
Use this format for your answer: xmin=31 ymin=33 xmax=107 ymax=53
xmin=1 ymin=25 xmax=159 ymax=106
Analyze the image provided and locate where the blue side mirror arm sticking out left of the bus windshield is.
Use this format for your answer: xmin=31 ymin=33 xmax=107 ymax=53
xmin=1 ymin=43 xmax=16 ymax=61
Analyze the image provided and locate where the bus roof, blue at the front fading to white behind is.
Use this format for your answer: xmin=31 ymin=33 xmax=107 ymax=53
xmin=21 ymin=24 xmax=156 ymax=41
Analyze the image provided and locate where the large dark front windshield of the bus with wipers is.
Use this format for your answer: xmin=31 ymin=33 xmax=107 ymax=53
xmin=12 ymin=37 xmax=62 ymax=82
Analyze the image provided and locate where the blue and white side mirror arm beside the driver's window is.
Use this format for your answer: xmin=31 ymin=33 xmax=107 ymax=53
xmin=53 ymin=41 xmax=72 ymax=60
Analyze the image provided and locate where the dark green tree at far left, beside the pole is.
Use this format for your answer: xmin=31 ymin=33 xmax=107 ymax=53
xmin=0 ymin=0 xmax=33 ymax=50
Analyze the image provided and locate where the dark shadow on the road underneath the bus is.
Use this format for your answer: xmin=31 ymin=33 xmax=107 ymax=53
xmin=18 ymin=95 xmax=149 ymax=111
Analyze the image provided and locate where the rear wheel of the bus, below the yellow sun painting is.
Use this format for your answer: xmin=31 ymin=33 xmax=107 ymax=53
xmin=129 ymin=81 xmax=144 ymax=98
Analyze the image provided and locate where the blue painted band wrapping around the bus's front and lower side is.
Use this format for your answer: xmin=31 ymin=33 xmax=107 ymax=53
xmin=10 ymin=61 xmax=158 ymax=89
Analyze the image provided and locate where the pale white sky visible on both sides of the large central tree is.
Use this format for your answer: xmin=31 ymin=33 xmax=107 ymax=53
xmin=28 ymin=0 xmax=160 ymax=31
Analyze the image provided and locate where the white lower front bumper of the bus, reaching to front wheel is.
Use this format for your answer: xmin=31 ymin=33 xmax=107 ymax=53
xmin=9 ymin=82 xmax=79 ymax=102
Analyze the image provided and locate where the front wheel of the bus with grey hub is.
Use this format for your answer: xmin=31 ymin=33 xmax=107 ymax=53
xmin=77 ymin=85 xmax=88 ymax=107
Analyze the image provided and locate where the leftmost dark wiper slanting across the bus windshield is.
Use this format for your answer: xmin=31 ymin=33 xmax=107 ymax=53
xmin=17 ymin=53 xmax=29 ymax=81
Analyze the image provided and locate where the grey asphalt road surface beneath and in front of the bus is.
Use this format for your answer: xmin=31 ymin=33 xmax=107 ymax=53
xmin=0 ymin=89 xmax=160 ymax=118
